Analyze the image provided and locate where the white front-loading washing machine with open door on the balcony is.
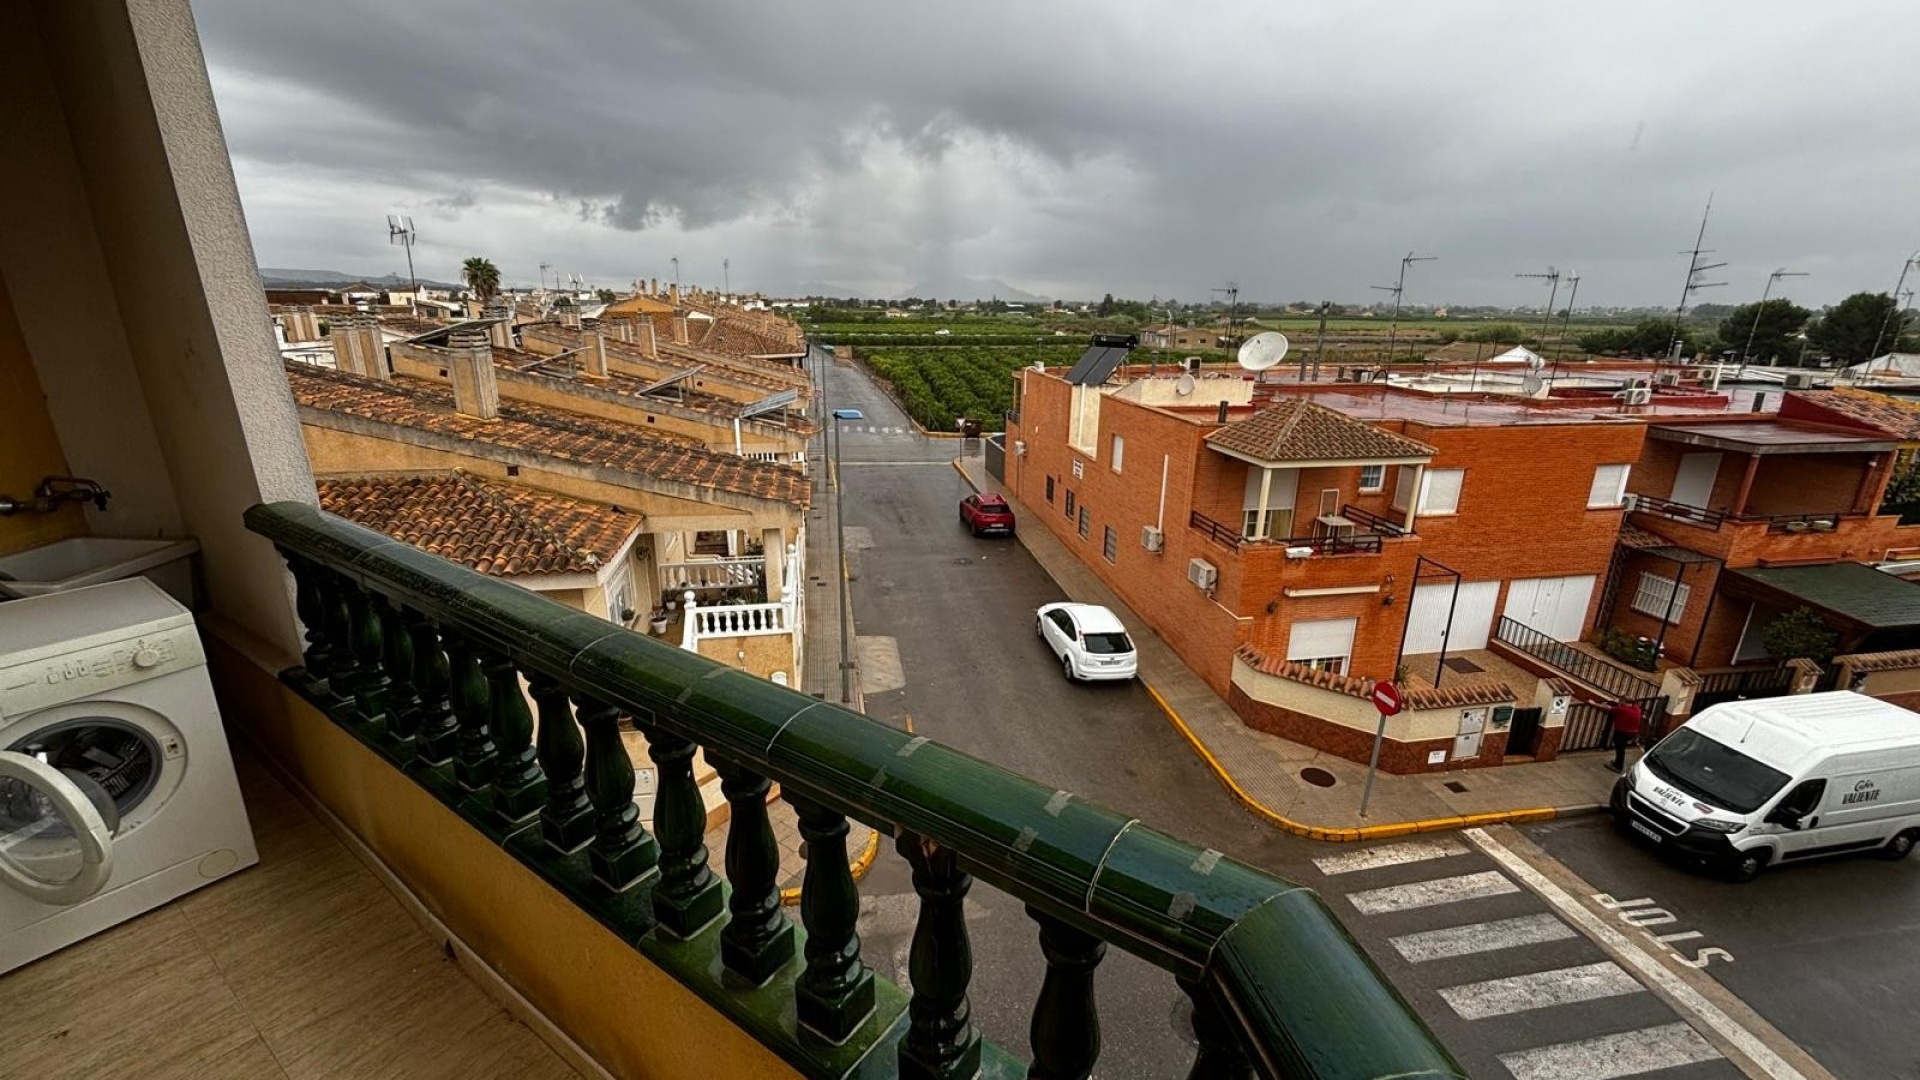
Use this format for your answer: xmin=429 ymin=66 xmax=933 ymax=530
xmin=0 ymin=578 xmax=259 ymax=974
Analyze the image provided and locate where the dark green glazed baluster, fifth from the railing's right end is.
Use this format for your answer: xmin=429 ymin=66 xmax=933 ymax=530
xmin=708 ymin=755 xmax=793 ymax=986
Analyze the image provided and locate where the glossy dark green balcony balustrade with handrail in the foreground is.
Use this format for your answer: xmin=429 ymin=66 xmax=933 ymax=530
xmin=248 ymin=503 xmax=1465 ymax=1080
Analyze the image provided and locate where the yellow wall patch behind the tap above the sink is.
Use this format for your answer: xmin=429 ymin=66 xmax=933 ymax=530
xmin=0 ymin=281 xmax=86 ymax=555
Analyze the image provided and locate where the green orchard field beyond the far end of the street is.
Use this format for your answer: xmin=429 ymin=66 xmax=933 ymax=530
xmin=864 ymin=338 xmax=1087 ymax=430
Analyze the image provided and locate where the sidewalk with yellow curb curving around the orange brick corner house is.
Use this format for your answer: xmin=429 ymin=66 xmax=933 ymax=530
xmin=954 ymin=445 xmax=1615 ymax=840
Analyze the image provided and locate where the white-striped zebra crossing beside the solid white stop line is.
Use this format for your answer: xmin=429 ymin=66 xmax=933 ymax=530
xmin=1313 ymin=836 xmax=1741 ymax=1080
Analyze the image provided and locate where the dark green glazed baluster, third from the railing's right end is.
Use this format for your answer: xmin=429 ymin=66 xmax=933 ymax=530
xmin=895 ymin=832 xmax=979 ymax=1080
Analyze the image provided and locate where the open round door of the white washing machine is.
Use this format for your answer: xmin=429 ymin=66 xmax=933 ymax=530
xmin=0 ymin=749 xmax=113 ymax=905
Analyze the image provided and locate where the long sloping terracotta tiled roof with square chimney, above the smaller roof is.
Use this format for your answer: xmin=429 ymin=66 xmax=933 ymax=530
xmin=286 ymin=363 xmax=808 ymax=505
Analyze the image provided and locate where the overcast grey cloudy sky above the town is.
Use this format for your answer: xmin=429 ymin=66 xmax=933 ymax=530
xmin=196 ymin=0 xmax=1920 ymax=307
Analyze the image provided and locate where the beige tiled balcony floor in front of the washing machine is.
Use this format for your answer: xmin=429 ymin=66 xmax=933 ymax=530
xmin=0 ymin=748 xmax=580 ymax=1080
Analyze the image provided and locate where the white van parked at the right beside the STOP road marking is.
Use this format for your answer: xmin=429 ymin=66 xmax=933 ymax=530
xmin=1613 ymin=692 xmax=1920 ymax=880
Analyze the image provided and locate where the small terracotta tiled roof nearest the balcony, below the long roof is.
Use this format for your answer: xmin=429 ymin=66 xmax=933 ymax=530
xmin=319 ymin=469 xmax=643 ymax=577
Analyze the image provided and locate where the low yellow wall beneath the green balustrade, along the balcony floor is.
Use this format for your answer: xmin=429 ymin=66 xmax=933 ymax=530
xmin=207 ymin=638 xmax=799 ymax=1080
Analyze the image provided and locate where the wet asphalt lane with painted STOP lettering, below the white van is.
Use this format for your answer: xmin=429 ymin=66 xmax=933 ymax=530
xmin=1523 ymin=807 xmax=1920 ymax=1078
